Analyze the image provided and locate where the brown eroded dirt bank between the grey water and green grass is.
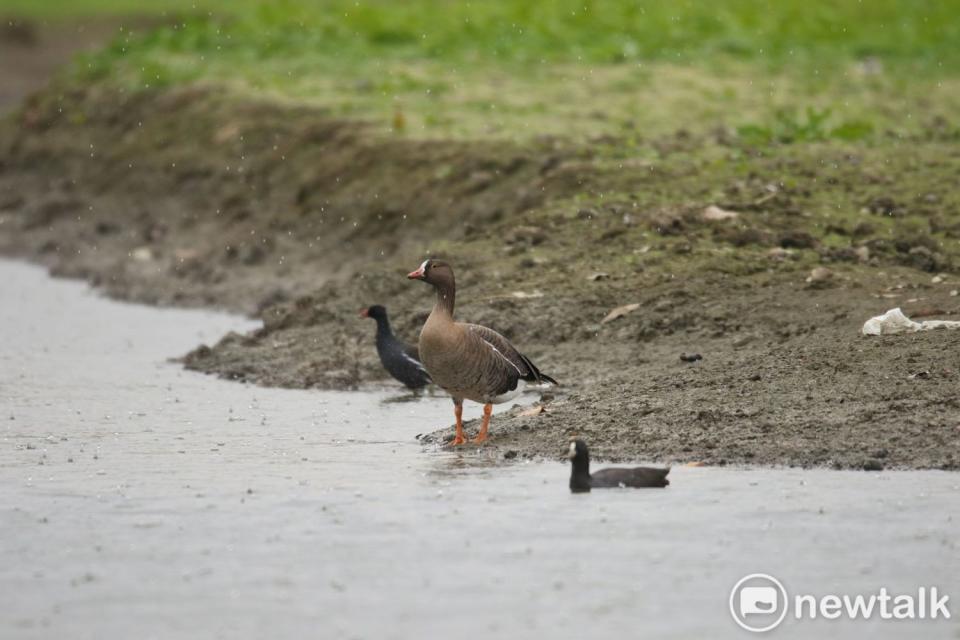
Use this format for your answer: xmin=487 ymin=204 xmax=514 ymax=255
xmin=0 ymin=82 xmax=960 ymax=469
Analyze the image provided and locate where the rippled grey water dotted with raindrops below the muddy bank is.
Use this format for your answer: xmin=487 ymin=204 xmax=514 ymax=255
xmin=0 ymin=262 xmax=960 ymax=639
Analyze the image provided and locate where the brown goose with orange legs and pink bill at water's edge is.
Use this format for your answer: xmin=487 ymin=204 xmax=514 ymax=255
xmin=407 ymin=260 xmax=557 ymax=445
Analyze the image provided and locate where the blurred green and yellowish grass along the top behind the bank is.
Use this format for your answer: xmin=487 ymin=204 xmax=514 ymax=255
xmin=0 ymin=0 xmax=960 ymax=142
